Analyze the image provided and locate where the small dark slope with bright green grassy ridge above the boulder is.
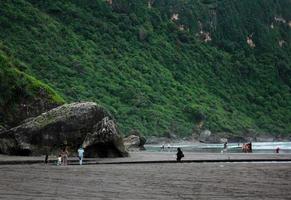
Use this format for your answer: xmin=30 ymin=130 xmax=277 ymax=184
xmin=0 ymin=45 xmax=64 ymax=129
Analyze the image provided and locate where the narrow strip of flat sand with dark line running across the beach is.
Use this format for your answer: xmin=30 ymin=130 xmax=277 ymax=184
xmin=0 ymin=152 xmax=291 ymax=165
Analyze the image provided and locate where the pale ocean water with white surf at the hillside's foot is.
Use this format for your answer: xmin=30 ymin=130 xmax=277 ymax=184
xmin=145 ymin=142 xmax=291 ymax=153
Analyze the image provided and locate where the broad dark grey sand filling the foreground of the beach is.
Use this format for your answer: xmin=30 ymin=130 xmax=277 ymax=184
xmin=0 ymin=154 xmax=291 ymax=199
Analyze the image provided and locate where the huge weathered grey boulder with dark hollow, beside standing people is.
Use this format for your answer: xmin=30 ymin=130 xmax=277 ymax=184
xmin=0 ymin=102 xmax=127 ymax=157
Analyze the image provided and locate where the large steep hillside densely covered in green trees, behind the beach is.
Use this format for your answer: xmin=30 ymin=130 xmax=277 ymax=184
xmin=0 ymin=0 xmax=291 ymax=136
